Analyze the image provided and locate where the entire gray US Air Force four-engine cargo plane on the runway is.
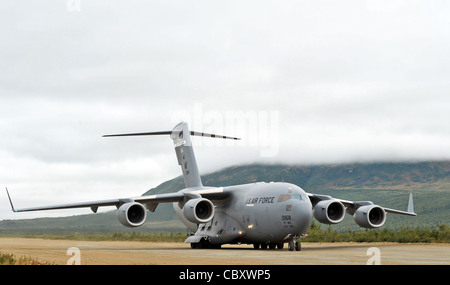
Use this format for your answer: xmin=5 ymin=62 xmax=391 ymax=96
xmin=6 ymin=122 xmax=416 ymax=251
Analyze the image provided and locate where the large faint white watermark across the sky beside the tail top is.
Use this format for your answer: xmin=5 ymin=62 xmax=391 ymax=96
xmin=172 ymin=103 xmax=280 ymax=157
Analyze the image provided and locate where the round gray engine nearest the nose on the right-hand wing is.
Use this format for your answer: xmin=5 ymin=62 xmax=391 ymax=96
xmin=313 ymin=200 xmax=345 ymax=225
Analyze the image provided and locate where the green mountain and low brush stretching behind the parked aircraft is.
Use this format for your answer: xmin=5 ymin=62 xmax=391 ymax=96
xmin=0 ymin=161 xmax=450 ymax=234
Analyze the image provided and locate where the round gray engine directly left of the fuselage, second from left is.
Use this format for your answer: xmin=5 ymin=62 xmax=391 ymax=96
xmin=183 ymin=198 xmax=214 ymax=224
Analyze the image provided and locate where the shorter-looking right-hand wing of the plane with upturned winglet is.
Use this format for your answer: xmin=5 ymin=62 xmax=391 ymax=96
xmin=306 ymin=193 xmax=417 ymax=216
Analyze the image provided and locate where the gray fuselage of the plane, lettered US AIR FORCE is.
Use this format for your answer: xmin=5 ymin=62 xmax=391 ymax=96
xmin=173 ymin=182 xmax=313 ymax=244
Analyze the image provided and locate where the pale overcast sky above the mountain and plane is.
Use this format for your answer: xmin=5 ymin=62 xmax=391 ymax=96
xmin=0 ymin=0 xmax=450 ymax=219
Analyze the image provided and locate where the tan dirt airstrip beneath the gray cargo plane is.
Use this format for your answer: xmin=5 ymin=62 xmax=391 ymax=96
xmin=0 ymin=235 xmax=450 ymax=265
